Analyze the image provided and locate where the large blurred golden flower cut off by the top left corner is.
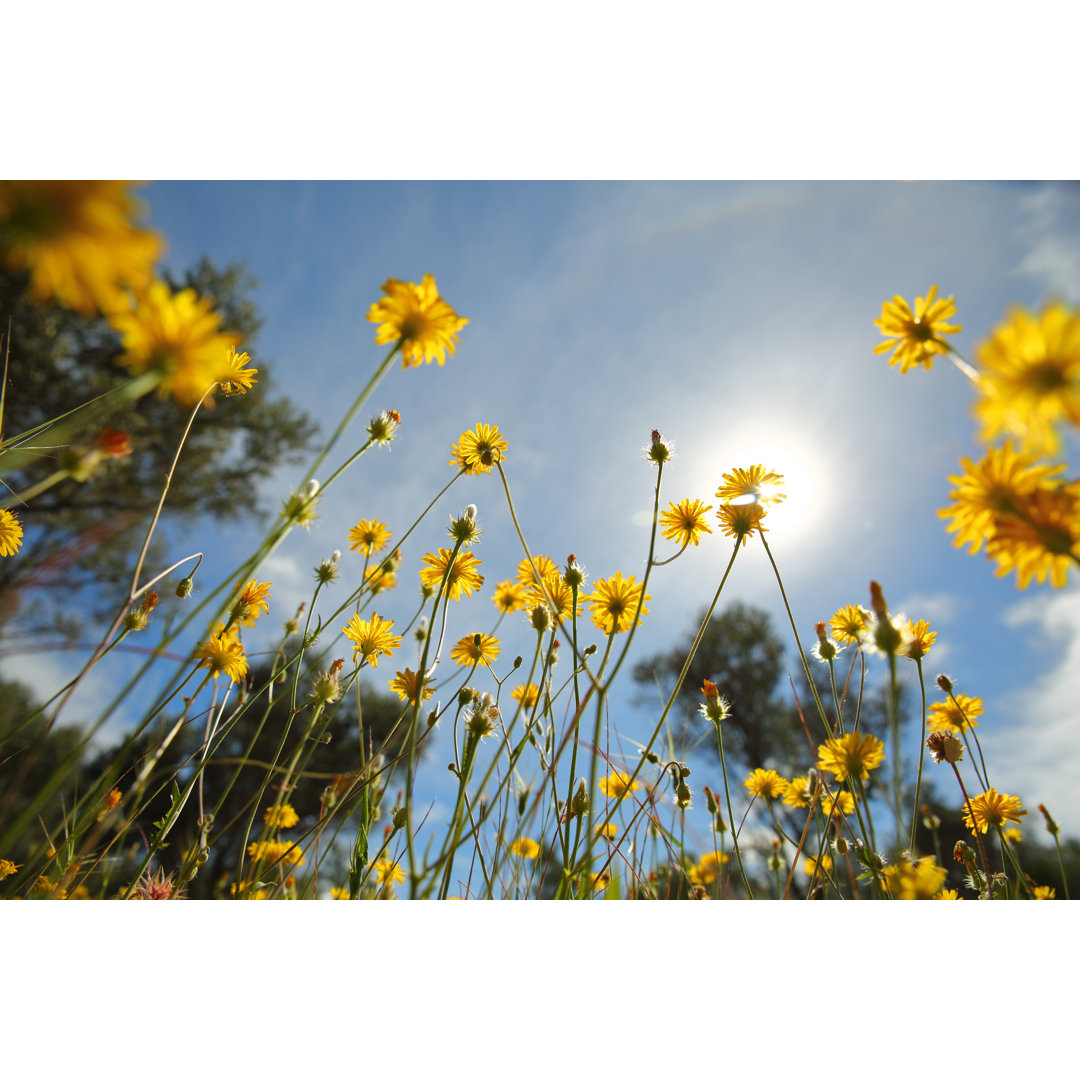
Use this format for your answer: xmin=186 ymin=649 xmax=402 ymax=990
xmin=0 ymin=180 xmax=162 ymax=315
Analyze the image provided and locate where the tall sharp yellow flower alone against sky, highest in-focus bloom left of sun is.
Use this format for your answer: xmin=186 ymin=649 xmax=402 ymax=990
xmin=367 ymin=273 xmax=469 ymax=367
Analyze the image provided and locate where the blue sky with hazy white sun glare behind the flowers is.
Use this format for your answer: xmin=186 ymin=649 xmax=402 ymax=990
xmin=8 ymin=181 xmax=1080 ymax=846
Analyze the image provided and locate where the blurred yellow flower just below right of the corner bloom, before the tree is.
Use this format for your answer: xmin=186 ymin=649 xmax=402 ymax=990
xmin=109 ymin=281 xmax=241 ymax=408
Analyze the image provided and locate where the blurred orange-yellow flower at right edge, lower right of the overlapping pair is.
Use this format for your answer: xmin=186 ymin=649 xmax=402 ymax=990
xmin=986 ymin=481 xmax=1080 ymax=589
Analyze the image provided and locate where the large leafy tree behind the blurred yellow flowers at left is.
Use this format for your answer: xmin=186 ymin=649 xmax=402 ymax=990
xmin=0 ymin=259 xmax=316 ymax=637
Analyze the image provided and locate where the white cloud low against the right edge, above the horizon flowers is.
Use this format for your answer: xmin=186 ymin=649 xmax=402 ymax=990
xmin=983 ymin=589 xmax=1080 ymax=835
